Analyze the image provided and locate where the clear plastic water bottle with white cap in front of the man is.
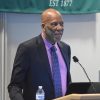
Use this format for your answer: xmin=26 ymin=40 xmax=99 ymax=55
xmin=36 ymin=86 xmax=45 ymax=100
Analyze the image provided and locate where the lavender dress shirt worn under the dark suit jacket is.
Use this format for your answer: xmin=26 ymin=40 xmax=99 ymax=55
xmin=42 ymin=33 xmax=67 ymax=96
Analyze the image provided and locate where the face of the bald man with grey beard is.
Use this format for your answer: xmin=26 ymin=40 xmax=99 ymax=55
xmin=43 ymin=15 xmax=64 ymax=44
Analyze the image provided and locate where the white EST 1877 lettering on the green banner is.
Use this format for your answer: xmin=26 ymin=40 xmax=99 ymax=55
xmin=49 ymin=0 xmax=73 ymax=7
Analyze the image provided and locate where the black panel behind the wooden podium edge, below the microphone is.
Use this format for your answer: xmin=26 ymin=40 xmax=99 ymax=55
xmin=67 ymin=82 xmax=100 ymax=94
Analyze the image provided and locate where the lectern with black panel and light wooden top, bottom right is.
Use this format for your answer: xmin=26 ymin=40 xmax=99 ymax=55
xmin=54 ymin=82 xmax=100 ymax=100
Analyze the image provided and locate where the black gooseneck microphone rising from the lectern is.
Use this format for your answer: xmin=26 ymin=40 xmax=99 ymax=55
xmin=73 ymin=56 xmax=96 ymax=93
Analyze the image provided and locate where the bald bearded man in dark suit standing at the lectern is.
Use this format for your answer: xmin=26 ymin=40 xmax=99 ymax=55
xmin=8 ymin=8 xmax=71 ymax=100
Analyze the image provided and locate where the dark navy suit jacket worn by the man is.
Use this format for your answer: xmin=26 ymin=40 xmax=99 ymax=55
xmin=8 ymin=35 xmax=71 ymax=100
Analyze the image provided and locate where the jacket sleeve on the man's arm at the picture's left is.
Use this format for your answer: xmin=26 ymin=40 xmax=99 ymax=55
xmin=8 ymin=44 xmax=29 ymax=100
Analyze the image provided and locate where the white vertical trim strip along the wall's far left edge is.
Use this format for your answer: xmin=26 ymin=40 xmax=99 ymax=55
xmin=1 ymin=13 xmax=8 ymax=100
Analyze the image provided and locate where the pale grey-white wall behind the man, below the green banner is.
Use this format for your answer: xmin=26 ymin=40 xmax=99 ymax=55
xmin=0 ymin=13 xmax=100 ymax=100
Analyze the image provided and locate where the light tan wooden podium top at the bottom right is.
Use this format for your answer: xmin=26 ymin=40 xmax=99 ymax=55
xmin=54 ymin=94 xmax=100 ymax=100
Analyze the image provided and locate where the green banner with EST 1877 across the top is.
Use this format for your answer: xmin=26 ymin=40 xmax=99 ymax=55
xmin=0 ymin=0 xmax=100 ymax=14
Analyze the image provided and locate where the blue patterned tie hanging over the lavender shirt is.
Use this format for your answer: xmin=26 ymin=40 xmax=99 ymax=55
xmin=50 ymin=46 xmax=62 ymax=98
